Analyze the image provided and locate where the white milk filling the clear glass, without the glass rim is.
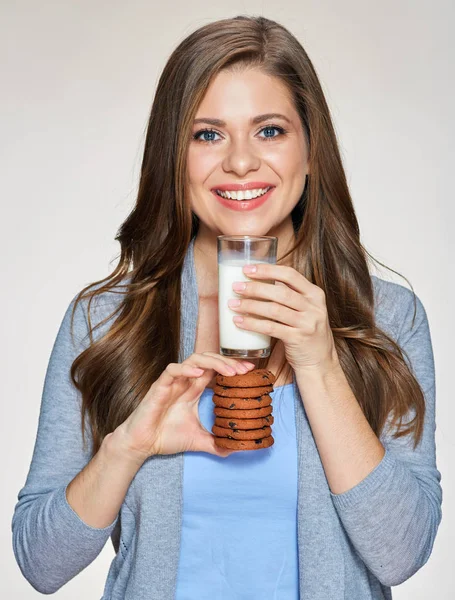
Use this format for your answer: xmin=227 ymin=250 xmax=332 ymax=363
xmin=218 ymin=259 xmax=270 ymax=350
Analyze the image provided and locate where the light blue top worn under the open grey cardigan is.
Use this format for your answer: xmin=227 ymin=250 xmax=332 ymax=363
xmin=175 ymin=383 xmax=299 ymax=600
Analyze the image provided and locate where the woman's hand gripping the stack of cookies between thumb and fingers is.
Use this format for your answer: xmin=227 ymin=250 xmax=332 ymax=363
xmin=112 ymin=352 xmax=255 ymax=464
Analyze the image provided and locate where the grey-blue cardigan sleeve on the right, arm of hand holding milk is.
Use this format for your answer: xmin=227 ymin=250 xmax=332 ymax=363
xmin=330 ymin=284 xmax=442 ymax=586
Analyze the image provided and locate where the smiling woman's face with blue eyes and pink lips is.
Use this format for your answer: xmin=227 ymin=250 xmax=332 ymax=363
xmin=188 ymin=69 xmax=308 ymax=235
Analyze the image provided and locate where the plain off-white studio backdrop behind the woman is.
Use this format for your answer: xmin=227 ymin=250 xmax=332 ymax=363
xmin=0 ymin=0 xmax=455 ymax=600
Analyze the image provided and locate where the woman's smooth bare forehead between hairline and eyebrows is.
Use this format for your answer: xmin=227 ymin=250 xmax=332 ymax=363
xmin=196 ymin=68 xmax=297 ymax=123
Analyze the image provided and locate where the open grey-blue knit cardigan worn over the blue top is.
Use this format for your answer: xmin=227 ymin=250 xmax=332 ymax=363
xmin=12 ymin=239 xmax=442 ymax=600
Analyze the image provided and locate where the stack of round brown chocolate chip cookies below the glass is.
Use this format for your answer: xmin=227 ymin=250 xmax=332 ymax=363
xmin=212 ymin=369 xmax=276 ymax=450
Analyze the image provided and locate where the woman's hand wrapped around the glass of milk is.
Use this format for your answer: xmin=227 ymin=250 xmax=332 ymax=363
xmin=229 ymin=263 xmax=338 ymax=371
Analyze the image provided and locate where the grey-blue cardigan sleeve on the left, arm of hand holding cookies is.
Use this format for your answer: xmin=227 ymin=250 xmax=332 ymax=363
xmin=12 ymin=297 xmax=118 ymax=594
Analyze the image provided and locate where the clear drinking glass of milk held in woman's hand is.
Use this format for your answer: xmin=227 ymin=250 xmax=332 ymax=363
xmin=217 ymin=235 xmax=278 ymax=358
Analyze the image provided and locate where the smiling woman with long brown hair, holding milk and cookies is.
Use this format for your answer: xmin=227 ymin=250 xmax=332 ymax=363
xmin=12 ymin=16 xmax=442 ymax=600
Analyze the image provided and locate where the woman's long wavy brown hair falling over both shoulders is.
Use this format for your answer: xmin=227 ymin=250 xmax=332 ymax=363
xmin=71 ymin=15 xmax=425 ymax=455
